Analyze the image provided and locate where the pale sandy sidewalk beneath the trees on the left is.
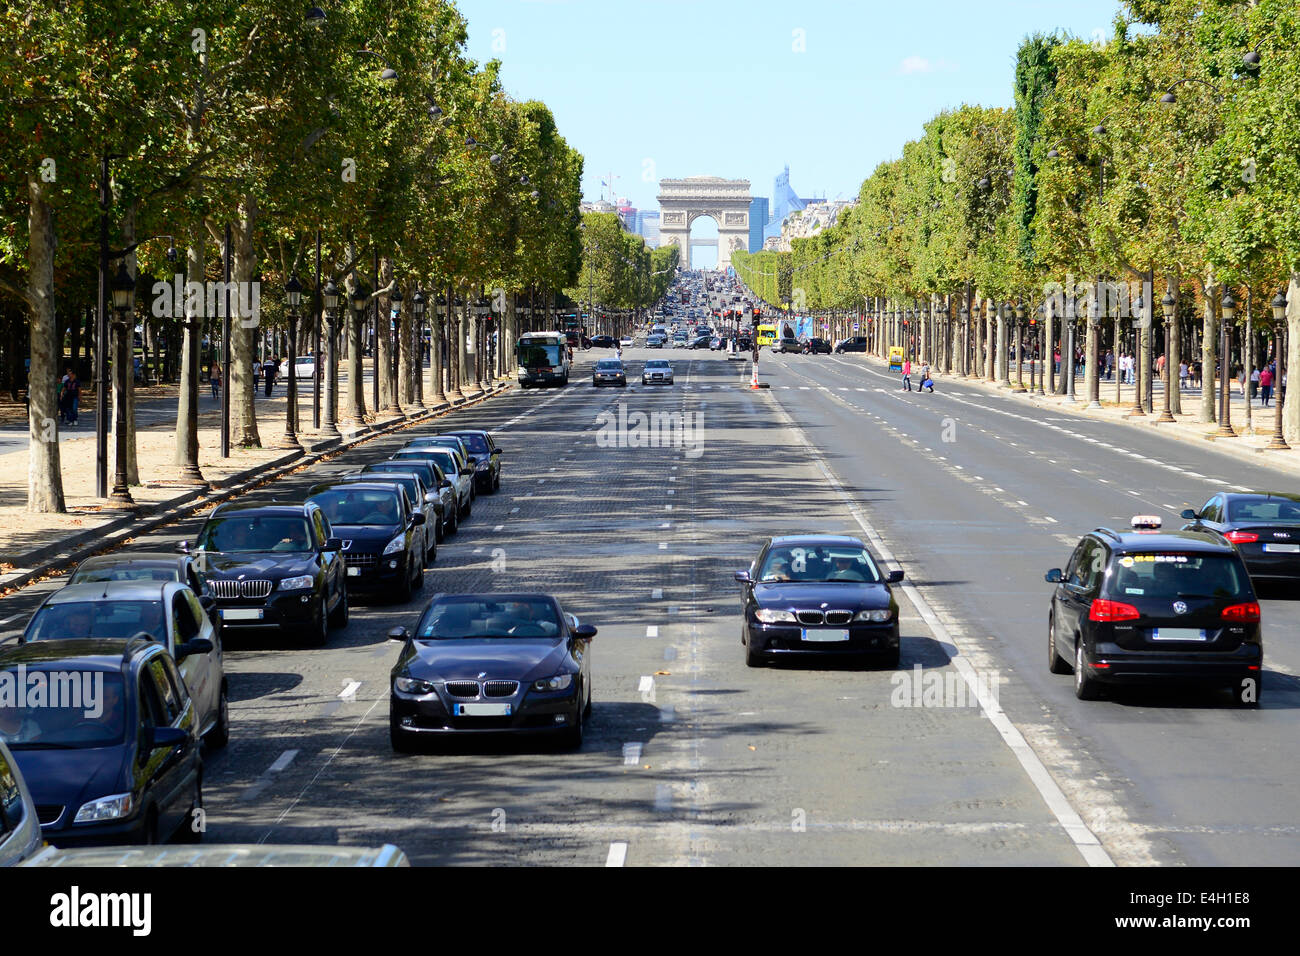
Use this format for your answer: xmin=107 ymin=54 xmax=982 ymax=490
xmin=0 ymin=364 xmax=510 ymax=592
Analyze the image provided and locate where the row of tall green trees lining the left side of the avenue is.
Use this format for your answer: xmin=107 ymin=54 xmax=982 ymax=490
xmin=0 ymin=0 xmax=582 ymax=511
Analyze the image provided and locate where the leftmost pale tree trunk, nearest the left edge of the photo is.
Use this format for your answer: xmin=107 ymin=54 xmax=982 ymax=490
xmin=26 ymin=176 xmax=68 ymax=514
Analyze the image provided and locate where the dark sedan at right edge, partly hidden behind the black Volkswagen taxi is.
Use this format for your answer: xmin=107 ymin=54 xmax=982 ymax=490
xmin=1183 ymin=492 xmax=1300 ymax=584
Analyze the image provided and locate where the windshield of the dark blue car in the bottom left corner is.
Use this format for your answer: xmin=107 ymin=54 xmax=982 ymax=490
xmin=0 ymin=669 xmax=126 ymax=750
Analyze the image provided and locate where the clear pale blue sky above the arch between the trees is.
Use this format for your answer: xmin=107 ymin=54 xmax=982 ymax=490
xmin=458 ymin=0 xmax=1121 ymax=265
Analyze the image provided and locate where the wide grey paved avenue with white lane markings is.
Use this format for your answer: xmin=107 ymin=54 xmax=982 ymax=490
xmin=0 ymin=349 xmax=1300 ymax=865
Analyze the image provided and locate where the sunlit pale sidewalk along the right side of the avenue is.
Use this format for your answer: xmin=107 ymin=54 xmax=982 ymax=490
xmin=866 ymin=354 xmax=1300 ymax=475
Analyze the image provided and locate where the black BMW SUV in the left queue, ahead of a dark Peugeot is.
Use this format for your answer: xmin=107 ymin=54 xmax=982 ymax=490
xmin=177 ymin=501 xmax=348 ymax=646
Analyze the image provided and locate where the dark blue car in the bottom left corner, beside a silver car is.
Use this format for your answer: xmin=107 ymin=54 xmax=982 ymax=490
xmin=0 ymin=637 xmax=203 ymax=847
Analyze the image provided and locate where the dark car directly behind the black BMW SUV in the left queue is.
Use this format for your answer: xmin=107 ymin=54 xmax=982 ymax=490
xmin=307 ymin=480 xmax=424 ymax=604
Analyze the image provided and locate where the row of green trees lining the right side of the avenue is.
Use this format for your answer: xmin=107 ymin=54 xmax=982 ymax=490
xmin=733 ymin=0 xmax=1300 ymax=440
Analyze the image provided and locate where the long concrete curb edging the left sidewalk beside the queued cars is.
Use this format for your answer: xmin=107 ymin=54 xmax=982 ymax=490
xmin=0 ymin=382 xmax=511 ymax=593
